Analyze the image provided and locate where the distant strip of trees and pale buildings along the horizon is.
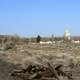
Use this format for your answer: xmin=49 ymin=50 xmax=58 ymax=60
xmin=0 ymin=29 xmax=80 ymax=44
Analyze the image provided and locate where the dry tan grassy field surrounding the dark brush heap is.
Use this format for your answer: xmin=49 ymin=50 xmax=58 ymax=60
xmin=0 ymin=43 xmax=80 ymax=80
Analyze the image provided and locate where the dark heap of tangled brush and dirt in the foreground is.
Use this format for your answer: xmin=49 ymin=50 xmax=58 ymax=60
xmin=11 ymin=62 xmax=73 ymax=80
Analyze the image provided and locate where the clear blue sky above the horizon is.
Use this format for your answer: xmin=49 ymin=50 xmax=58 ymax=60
xmin=0 ymin=0 xmax=80 ymax=37
